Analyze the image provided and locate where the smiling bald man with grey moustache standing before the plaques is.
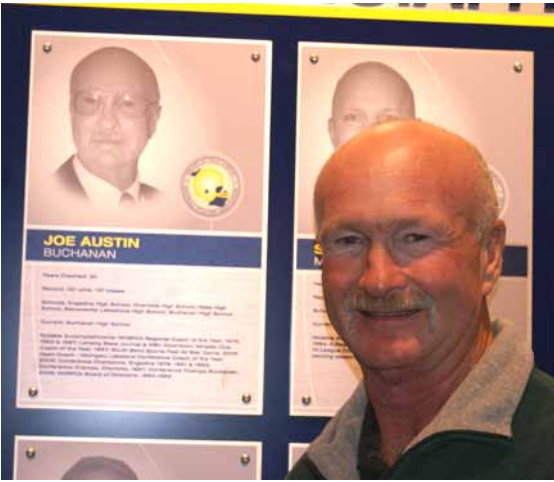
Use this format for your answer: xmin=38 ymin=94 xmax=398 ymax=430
xmin=289 ymin=120 xmax=554 ymax=479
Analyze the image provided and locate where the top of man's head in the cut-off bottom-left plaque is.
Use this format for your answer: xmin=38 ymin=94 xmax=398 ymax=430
xmin=61 ymin=456 xmax=138 ymax=480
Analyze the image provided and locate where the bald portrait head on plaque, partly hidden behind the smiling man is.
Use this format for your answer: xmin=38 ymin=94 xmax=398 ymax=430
xmin=327 ymin=62 xmax=415 ymax=149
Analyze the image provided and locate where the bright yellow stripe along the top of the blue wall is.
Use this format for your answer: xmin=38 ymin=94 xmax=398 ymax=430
xmin=47 ymin=3 xmax=554 ymax=28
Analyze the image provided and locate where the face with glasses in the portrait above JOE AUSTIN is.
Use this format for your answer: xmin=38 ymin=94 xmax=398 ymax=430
xmin=71 ymin=50 xmax=159 ymax=183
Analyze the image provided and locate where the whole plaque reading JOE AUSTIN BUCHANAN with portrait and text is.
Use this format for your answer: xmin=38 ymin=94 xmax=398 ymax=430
xmin=17 ymin=31 xmax=272 ymax=415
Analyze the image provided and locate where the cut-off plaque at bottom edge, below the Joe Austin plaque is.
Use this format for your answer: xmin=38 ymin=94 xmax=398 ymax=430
xmin=14 ymin=436 xmax=261 ymax=480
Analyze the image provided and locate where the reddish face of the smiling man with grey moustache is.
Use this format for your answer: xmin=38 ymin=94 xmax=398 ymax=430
xmin=318 ymin=133 xmax=498 ymax=370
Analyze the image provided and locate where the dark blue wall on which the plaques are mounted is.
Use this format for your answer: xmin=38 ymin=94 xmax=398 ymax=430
xmin=1 ymin=5 xmax=554 ymax=479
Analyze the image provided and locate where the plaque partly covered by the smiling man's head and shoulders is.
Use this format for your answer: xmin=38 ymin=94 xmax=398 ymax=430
xmin=290 ymin=42 xmax=533 ymax=416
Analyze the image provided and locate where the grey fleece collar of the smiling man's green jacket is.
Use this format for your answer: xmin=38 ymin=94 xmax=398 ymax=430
xmin=307 ymin=321 xmax=533 ymax=479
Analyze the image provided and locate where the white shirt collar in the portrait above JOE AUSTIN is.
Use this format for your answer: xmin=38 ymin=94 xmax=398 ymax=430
xmin=73 ymin=156 xmax=141 ymax=209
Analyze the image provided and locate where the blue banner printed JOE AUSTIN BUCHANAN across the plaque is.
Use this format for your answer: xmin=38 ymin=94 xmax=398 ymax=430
xmin=26 ymin=229 xmax=262 ymax=268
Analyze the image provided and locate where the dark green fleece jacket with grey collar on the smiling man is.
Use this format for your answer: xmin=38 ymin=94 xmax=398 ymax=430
xmin=287 ymin=322 xmax=554 ymax=479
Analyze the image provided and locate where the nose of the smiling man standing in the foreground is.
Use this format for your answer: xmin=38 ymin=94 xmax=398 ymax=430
xmin=358 ymin=246 xmax=406 ymax=297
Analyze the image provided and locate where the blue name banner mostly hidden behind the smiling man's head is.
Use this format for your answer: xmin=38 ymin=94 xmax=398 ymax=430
xmin=296 ymin=239 xmax=527 ymax=276
